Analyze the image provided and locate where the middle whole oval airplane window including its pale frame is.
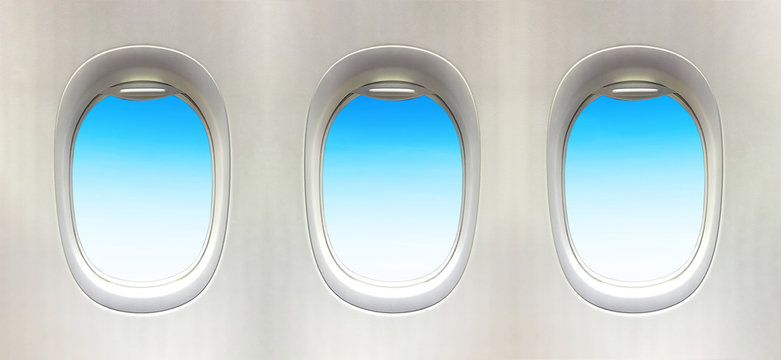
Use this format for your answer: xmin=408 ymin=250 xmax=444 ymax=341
xmin=304 ymin=46 xmax=480 ymax=313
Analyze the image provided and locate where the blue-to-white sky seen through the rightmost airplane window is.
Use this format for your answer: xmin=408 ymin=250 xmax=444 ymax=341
xmin=564 ymin=96 xmax=705 ymax=281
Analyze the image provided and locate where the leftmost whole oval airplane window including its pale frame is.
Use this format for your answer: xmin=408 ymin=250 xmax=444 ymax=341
xmin=54 ymin=45 xmax=230 ymax=313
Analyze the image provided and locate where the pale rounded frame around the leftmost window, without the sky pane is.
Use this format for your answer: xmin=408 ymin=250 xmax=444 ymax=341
xmin=54 ymin=45 xmax=230 ymax=313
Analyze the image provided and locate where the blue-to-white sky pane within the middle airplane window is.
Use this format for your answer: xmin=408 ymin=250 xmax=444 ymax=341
xmin=323 ymin=96 xmax=462 ymax=281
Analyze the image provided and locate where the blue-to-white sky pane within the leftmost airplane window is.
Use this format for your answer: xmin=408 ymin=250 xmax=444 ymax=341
xmin=73 ymin=96 xmax=212 ymax=282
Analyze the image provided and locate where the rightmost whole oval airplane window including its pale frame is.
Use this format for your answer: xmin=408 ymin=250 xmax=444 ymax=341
xmin=547 ymin=45 xmax=723 ymax=313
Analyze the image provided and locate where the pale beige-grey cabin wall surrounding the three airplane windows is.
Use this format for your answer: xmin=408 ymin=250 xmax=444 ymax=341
xmin=0 ymin=0 xmax=781 ymax=359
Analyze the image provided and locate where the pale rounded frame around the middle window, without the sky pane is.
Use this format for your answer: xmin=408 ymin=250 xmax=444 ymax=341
xmin=304 ymin=45 xmax=480 ymax=313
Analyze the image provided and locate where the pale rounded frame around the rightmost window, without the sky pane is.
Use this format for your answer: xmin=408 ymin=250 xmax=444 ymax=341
xmin=547 ymin=45 xmax=723 ymax=313
